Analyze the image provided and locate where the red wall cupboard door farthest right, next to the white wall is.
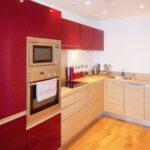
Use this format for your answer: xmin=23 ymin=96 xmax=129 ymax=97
xmin=93 ymin=29 xmax=104 ymax=51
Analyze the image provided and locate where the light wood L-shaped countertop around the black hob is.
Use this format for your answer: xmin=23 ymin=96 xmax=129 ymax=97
xmin=61 ymin=75 xmax=150 ymax=98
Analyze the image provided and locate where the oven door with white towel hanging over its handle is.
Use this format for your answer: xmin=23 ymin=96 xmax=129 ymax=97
xmin=30 ymin=78 xmax=60 ymax=115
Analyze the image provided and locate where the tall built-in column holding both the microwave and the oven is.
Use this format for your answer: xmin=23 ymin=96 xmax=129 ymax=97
xmin=27 ymin=37 xmax=61 ymax=128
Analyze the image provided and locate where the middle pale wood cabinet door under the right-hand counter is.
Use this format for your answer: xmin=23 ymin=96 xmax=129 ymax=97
xmin=125 ymin=83 xmax=144 ymax=120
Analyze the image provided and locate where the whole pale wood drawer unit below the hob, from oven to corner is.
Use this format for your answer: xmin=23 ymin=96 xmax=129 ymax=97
xmin=61 ymin=81 xmax=104 ymax=145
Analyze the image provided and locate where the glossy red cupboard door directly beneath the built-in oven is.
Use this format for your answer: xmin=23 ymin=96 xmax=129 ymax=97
xmin=27 ymin=114 xmax=61 ymax=150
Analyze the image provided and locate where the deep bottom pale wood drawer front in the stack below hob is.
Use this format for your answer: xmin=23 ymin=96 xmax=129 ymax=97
xmin=61 ymin=105 xmax=91 ymax=145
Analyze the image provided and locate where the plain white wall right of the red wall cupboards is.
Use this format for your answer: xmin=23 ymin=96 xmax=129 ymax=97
xmin=93 ymin=16 xmax=150 ymax=73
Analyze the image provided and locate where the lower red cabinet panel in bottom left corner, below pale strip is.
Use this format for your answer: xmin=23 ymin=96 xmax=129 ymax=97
xmin=0 ymin=116 xmax=26 ymax=150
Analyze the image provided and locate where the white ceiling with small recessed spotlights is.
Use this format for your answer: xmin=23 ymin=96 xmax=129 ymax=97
xmin=36 ymin=0 xmax=150 ymax=20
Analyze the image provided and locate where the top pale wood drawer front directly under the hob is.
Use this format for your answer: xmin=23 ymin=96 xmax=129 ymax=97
xmin=61 ymin=88 xmax=90 ymax=109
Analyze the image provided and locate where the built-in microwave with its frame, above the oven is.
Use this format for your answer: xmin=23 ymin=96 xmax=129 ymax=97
xmin=27 ymin=37 xmax=61 ymax=67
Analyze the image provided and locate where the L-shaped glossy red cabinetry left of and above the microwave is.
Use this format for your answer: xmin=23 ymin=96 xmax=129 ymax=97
xmin=0 ymin=0 xmax=61 ymax=119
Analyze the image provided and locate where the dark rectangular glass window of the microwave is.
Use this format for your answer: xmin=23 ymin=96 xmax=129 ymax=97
xmin=33 ymin=45 xmax=53 ymax=63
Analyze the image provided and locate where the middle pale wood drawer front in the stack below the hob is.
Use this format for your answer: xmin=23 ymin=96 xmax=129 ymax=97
xmin=61 ymin=96 xmax=91 ymax=120
